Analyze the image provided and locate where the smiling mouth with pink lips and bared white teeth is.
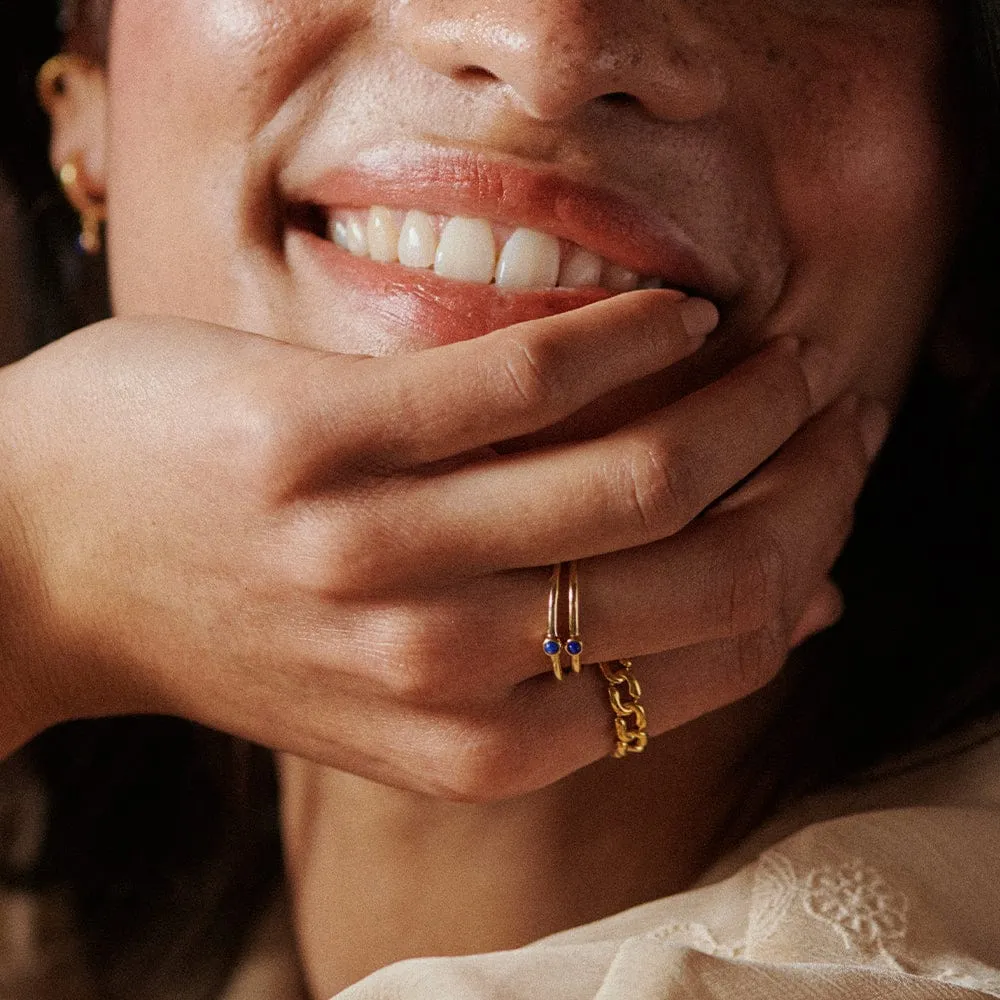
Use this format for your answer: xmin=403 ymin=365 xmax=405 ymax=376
xmin=277 ymin=144 xmax=734 ymax=354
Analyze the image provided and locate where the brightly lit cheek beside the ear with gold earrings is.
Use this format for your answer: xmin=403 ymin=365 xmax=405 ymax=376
xmin=102 ymin=0 xmax=350 ymax=329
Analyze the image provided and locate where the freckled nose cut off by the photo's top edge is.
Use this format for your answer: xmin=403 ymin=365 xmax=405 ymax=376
xmin=393 ymin=0 xmax=724 ymax=122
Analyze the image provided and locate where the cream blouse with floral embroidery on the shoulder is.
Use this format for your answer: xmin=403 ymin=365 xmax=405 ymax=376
xmin=225 ymin=719 xmax=1000 ymax=1000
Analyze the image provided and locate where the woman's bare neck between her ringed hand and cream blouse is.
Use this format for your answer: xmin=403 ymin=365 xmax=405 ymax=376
xmin=280 ymin=697 xmax=771 ymax=998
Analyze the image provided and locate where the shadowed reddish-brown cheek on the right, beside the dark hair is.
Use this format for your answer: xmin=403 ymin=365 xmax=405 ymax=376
xmin=756 ymin=12 xmax=957 ymax=398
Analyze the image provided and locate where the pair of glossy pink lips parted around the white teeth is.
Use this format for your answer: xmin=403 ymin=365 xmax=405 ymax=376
xmin=285 ymin=150 xmax=719 ymax=346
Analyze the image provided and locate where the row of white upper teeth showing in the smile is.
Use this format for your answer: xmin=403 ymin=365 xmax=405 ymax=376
xmin=329 ymin=205 xmax=664 ymax=292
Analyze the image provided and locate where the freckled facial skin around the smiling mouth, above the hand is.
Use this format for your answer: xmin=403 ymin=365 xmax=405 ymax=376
xmin=110 ymin=0 xmax=953 ymax=414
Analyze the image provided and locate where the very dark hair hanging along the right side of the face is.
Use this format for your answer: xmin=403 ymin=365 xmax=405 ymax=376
xmin=786 ymin=0 xmax=1000 ymax=781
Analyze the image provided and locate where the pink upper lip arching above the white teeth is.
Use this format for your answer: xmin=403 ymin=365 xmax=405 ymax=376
xmin=279 ymin=146 xmax=734 ymax=301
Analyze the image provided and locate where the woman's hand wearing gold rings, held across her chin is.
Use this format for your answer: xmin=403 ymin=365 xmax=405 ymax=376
xmin=0 ymin=292 xmax=865 ymax=799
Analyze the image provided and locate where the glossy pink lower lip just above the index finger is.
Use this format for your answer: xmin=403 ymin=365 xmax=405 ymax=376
xmin=288 ymin=229 xmax=613 ymax=347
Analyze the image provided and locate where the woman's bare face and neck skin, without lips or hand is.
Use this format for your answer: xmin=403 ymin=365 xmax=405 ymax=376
xmin=97 ymin=0 xmax=960 ymax=996
